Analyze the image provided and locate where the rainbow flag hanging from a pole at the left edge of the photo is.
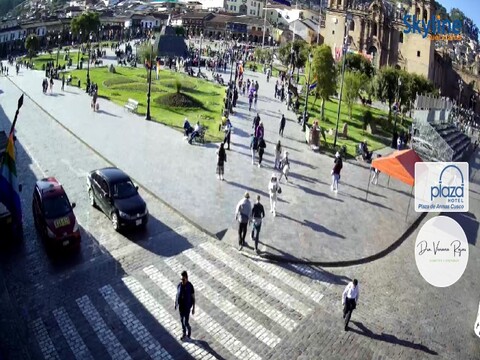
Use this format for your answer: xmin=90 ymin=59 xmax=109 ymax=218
xmin=0 ymin=131 xmax=22 ymax=225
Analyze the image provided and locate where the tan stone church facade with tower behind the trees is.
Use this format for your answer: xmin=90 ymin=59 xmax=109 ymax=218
xmin=324 ymin=0 xmax=435 ymax=81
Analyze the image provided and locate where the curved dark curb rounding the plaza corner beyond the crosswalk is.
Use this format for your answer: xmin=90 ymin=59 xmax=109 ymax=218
xmin=259 ymin=212 xmax=428 ymax=268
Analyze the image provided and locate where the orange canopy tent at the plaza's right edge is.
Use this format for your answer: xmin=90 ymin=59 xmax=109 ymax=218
xmin=367 ymin=149 xmax=423 ymax=220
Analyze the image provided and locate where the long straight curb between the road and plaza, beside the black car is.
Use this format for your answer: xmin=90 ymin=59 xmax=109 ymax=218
xmin=8 ymin=77 xmax=219 ymax=240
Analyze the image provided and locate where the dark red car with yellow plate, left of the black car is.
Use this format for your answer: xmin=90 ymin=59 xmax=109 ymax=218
xmin=32 ymin=177 xmax=80 ymax=247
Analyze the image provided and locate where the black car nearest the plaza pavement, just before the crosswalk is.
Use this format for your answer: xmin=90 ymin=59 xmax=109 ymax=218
xmin=87 ymin=167 xmax=148 ymax=231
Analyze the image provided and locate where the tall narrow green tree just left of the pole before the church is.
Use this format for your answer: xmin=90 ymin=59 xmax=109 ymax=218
xmin=312 ymin=44 xmax=337 ymax=120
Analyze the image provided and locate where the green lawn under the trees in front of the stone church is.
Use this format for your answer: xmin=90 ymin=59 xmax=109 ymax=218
xmin=300 ymin=96 xmax=411 ymax=156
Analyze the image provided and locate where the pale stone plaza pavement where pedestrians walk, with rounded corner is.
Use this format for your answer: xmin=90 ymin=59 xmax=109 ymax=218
xmin=2 ymin=58 xmax=418 ymax=263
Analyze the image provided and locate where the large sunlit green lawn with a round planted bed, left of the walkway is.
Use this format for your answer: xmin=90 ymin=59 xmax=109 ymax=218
xmin=67 ymin=67 xmax=225 ymax=141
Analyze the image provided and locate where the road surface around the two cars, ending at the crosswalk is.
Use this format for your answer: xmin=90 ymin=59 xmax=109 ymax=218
xmin=1 ymin=82 xmax=201 ymax=298
